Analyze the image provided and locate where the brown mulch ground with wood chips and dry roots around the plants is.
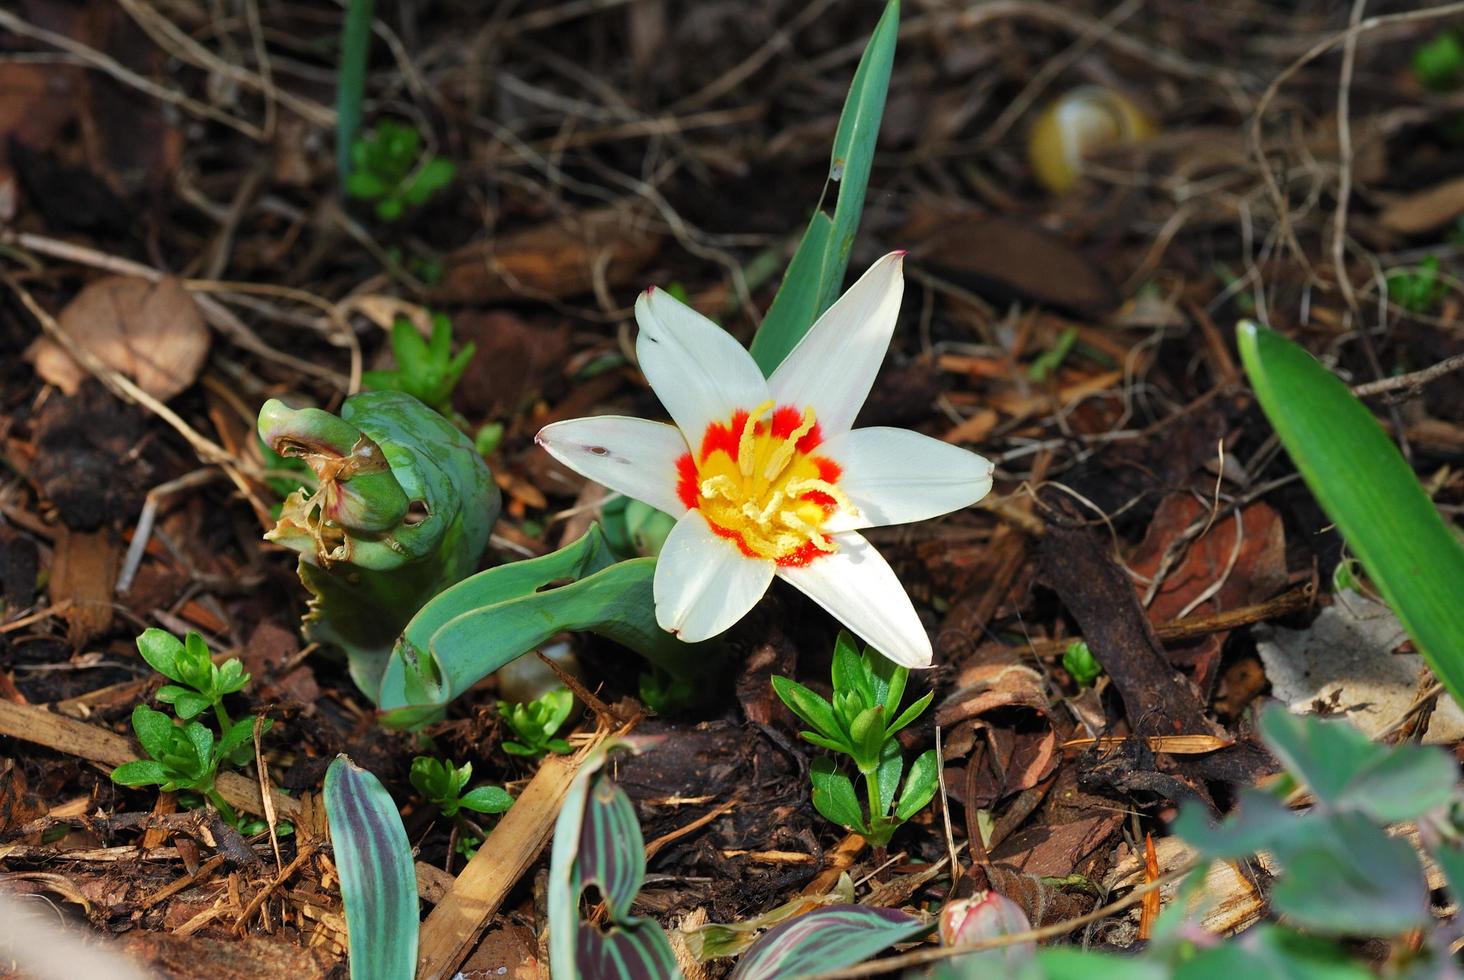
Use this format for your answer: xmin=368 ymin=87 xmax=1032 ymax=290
xmin=0 ymin=0 xmax=1464 ymax=979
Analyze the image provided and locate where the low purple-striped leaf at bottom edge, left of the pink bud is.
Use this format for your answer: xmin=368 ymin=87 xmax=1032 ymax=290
xmin=732 ymin=905 xmax=930 ymax=980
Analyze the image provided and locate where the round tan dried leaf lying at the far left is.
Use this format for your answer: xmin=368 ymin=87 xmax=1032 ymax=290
xmin=26 ymin=275 xmax=209 ymax=401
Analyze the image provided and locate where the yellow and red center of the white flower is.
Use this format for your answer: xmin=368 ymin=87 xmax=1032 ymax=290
xmin=676 ymin=401 xmax=858 ymax=567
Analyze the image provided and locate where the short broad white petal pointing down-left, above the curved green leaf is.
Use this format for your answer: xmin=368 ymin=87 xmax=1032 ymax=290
xmin=653 ymin=510 xmax=773 ymax=643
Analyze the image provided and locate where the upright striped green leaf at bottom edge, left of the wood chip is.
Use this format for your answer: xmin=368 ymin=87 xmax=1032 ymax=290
xmin=325 ymin=756 xmax=419 ymax=980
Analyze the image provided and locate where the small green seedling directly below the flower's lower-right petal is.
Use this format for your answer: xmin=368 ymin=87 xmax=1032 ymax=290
xmin=773 ymin=633 xmax=938 ymax=847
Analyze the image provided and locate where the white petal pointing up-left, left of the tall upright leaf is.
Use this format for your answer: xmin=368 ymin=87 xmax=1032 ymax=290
xmin=635 ymin=289 xmax=770 ymax=445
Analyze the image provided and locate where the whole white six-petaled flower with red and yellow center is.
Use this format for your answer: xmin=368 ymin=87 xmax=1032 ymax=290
xmin=537 ymin=252 xmax=991 ymax=667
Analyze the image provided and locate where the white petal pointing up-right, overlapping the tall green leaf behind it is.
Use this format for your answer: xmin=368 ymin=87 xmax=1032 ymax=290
xmin=767 ymin=252 xmax=905 ymax=438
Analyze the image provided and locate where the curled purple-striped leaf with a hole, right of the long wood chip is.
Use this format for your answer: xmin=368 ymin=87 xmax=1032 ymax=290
xmin=549 ymin=743 xmax=681 ymax=980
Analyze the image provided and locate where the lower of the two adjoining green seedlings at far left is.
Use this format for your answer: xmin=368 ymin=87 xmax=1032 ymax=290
xmin=111 ymin=705 xmax=255 ymax=825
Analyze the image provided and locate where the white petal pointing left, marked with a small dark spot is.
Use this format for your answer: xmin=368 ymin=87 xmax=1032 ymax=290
xmin=534 ymin=415 xmax=687 ymax=514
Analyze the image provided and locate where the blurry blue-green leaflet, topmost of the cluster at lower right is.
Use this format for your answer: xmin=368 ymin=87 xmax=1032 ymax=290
xmin=1261 ymin=705 xmax=1458 ymax=823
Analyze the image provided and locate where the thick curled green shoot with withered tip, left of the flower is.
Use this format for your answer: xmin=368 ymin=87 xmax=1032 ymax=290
xmin=259 ymin=391 xmax=501 ymax=700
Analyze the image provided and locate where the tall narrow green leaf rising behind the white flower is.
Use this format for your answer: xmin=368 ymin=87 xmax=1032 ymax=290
xmin=751 ymin=0 xmax=900 ymax=375
